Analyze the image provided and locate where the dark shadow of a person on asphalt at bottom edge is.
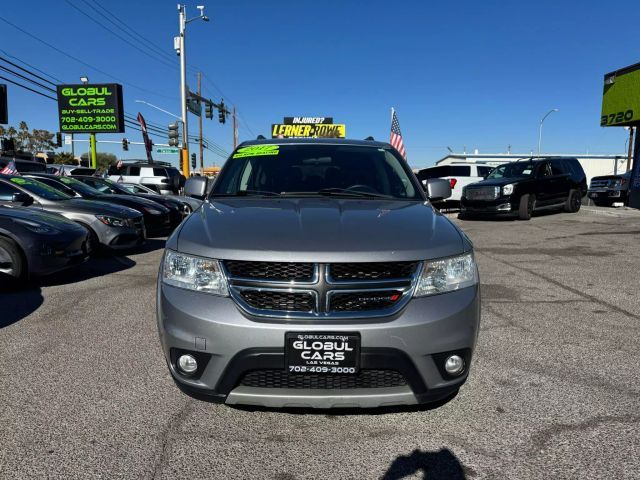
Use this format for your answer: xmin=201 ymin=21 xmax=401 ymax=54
xmin=382 ymin=448 xmax=467 ymax=480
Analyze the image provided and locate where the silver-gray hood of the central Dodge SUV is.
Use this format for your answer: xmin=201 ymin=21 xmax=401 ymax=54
xmin=174 ymin=198 xmax=468 ymax=262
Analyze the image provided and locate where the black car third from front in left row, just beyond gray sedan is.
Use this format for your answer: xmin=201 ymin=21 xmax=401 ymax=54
xmin=25 ymin=173 xmax=171 ymax=237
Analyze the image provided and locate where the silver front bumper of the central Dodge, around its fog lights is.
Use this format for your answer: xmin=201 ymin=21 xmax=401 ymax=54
xmin=157 ymin=285 xmax=480 ymax=408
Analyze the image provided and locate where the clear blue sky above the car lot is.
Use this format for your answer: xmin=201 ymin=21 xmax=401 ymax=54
xmin=0 ymin=0 xmax=640 ymax=166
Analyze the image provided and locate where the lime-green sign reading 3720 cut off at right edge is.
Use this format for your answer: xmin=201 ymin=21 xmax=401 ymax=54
xmin=600 ymin=63 xmax=640 ymax=127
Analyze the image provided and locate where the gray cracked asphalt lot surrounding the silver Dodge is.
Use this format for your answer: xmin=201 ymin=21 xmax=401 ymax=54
xmin=0 ymin=208 xmax=640 ymax=480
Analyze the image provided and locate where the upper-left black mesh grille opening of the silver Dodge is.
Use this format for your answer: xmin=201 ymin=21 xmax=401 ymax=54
xmin=224 ymin=260 xmax=314 ymax=282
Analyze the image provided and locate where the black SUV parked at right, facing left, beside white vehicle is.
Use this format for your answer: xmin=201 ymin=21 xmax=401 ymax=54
xmin=460 ymin=157 xmax=587 ymax=220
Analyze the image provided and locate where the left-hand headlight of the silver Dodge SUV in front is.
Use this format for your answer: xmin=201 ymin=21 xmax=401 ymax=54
xmin=162 ymin=250 xmax=229 ymax=297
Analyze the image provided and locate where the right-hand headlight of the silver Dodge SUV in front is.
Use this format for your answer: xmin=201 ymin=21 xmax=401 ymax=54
xmin=413 ymin=253 xmax=478 ymax=297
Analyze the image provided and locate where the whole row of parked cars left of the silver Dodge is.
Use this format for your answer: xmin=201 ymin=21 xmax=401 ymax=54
xmin=0 ymin=164 xmax=200 ymax=283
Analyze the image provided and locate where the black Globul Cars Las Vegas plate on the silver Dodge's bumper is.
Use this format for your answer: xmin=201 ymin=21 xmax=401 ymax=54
xmin=285 ymin=332 xmax=360 ymax=375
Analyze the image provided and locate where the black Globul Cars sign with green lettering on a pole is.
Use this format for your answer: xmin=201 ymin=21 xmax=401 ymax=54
xmin=57 ymin=83 xmax=124 ymax=133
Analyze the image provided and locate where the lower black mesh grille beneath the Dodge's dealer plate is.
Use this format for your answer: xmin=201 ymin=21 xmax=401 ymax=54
xmin=240 ymin=369 xmax=407 ymax=390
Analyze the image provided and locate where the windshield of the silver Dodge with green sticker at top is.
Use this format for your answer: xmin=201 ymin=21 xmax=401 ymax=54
xmin=211 ymin=144 xmax=424 ymax=201
